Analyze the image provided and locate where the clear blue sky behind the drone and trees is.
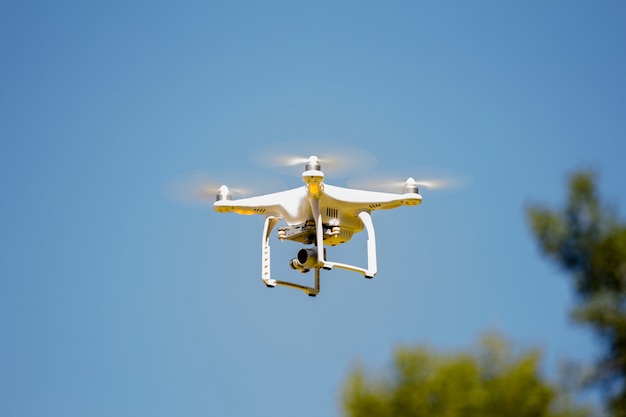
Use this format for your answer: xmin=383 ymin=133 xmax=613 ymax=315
xmin=0 ymin=1 xmax=626 ymax=417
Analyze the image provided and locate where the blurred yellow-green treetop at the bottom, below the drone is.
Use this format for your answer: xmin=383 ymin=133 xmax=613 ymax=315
xmin=342 ymin=334 xmax=589 ymax=417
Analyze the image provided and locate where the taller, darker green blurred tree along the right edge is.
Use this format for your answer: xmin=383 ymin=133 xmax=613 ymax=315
xmin=528 ymin=171 xmax=626 ymax=416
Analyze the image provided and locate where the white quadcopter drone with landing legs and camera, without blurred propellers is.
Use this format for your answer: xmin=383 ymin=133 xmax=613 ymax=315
xmin=213 ymin=156 xmax=422 ymax=297
